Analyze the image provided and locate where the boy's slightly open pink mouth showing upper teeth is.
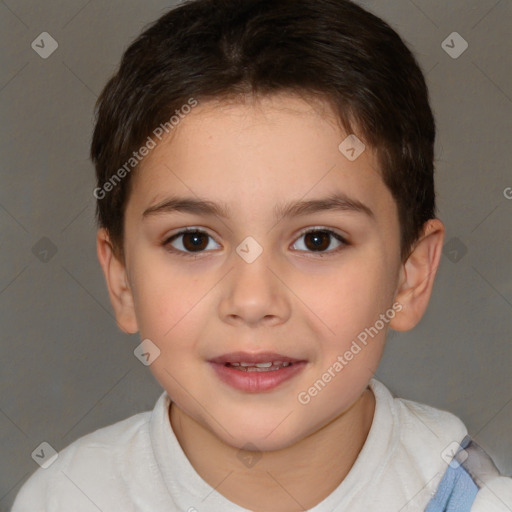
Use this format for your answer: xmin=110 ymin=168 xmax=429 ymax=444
xmin=208 ymin=352 xmax=307 ymax=393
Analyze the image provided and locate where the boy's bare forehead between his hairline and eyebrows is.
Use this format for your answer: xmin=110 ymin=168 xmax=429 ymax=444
xmin=126 ymin=94 xmax=394 ymax=226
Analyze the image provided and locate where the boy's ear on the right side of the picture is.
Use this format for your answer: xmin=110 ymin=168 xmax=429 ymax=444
xmin=389 ymin=219 xmax=445 ymax=331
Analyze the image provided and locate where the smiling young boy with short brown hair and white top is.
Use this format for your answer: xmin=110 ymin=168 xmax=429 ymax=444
xmin=12 ymin=0 xmax=512 ymax=512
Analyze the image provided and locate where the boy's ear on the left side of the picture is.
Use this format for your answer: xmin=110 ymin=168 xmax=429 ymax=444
xmin=96 ymin=228 xmax=139 ymax=334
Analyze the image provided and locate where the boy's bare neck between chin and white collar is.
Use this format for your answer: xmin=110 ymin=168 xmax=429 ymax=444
xmin=169 ymin=389 xmax=375 ymax=512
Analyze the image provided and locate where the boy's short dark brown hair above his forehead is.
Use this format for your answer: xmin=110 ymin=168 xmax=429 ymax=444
xmin=91 ymin=0 xmax=435 ymax=260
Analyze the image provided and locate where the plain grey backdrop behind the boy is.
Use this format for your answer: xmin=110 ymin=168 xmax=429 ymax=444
xmin=0 ymin=0 xmax=512 ymax=511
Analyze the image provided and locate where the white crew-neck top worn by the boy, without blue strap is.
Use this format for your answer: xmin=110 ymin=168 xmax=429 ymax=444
xmin=11 ymin=379 xmax=512 ymax=512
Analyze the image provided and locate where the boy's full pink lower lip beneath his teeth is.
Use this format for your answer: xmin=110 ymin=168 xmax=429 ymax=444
xmin=210 ymin=361 xmax=306 ymax=393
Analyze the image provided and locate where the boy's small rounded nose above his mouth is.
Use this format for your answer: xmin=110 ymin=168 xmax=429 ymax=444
xmin=219 ymin=247 xmax=291 ymax=327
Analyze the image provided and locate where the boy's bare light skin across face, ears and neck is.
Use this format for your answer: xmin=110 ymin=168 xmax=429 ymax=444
xmin=97 ymin=94 xmax=444 ymax=512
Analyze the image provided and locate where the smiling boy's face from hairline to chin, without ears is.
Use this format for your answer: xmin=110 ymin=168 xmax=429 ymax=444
xmin=118 ymin=95 xmax=401 ymax=450
